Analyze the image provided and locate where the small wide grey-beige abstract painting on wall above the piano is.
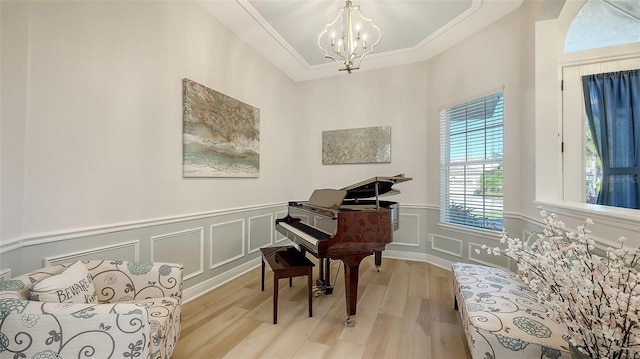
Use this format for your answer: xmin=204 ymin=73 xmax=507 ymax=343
xmin=322 ymin=126 xmax=391 ymax=165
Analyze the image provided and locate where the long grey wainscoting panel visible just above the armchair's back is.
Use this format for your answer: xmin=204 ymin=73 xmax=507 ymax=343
xmin=44 ymin=240 xmax=140 ymax=267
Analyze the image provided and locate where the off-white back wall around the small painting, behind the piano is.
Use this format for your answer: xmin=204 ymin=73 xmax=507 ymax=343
xmin=296 ymin=62 xmax=430 ymax=204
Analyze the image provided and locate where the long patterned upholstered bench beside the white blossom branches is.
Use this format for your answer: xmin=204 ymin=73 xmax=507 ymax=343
xmin=452 ymin=263 xmax=571 ymax=359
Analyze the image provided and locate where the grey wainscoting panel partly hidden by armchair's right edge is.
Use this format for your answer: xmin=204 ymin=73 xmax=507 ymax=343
xmin=149 ymin=227 xmax=204 ymax=280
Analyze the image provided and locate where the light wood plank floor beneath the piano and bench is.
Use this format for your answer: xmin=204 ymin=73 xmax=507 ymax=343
xmin=171 ymin=256 xmax=471 ymax=359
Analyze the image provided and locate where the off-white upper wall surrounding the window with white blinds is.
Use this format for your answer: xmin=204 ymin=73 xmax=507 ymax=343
xmin=427 ymin=2 xmax=539 ymax=217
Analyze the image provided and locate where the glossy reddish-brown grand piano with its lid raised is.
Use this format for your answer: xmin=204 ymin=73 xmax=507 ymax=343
xmin=276 ymin=174 xmax=411 ymax=327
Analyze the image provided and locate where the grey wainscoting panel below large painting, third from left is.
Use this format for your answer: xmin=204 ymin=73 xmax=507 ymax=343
xmin=209 ymin=219 xmax=246 ymax=269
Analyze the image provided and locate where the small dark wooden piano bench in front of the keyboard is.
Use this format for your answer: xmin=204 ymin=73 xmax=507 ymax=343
xmin=260 ymin=246 xmax=315 ymax=324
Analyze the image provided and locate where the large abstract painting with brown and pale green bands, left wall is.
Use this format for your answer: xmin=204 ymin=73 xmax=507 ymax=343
xmin=182 ymin=79 xmax=260 ymax=177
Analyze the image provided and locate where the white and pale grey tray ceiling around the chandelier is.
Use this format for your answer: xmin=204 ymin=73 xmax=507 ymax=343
xmin=198 ymin=0 xmax=564 ymax=81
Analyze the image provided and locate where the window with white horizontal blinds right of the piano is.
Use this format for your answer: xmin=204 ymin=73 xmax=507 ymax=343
xmin=440 ymin=92 xmax=504 ymax=230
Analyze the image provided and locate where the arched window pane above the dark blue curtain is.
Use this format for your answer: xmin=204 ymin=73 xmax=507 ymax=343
xmin=564 ymin=0 xmax=640 ymax=53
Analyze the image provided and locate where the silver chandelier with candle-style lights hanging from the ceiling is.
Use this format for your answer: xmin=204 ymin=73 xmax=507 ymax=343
xmin=318 ymin=0 xmax=382 ymax=73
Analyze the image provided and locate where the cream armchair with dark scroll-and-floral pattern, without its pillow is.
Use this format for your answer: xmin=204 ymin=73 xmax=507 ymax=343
xmin=0 ymin=260 xmax=183 ymax=359
